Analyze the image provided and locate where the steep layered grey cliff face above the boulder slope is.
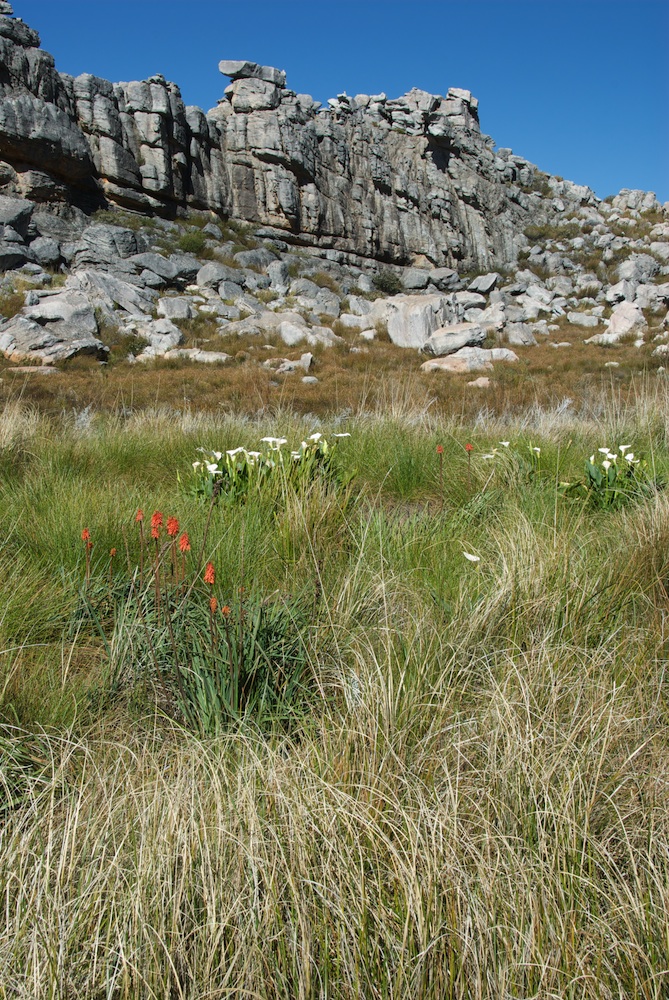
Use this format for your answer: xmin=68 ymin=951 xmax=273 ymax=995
xmin=0 ymin=3 xmax=596 ymax=269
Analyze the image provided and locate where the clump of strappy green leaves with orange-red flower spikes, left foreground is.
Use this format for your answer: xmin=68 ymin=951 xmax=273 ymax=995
xmin=81 ymin=511 xmax=308 ymax=735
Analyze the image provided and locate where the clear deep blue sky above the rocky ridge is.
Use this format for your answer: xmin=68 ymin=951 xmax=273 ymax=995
xmin=13 ymin=0 xmax=669 ymax=201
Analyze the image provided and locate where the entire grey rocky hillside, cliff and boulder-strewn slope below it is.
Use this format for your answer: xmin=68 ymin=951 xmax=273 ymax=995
xmin=0 ymin=0 xmax=669 ymax=378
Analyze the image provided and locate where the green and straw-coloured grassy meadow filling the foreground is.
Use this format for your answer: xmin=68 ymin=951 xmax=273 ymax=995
xmin=0 ymin=376 xmax=669 ymax=1000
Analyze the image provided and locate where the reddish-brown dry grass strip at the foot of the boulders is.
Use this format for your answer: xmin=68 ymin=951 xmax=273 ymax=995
xmin=0 ymin=320 xmax=657 ymax=418
